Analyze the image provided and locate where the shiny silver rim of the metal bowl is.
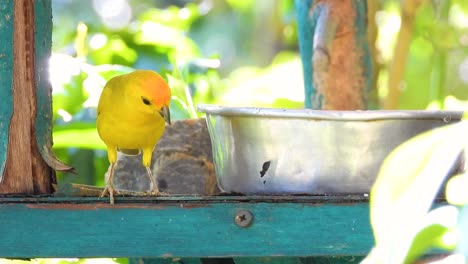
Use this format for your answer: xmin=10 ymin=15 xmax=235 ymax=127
xmin=197 ymin=104 xmax=463 ymax=122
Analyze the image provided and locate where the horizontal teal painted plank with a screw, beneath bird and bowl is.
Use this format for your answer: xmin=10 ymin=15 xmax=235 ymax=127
xmin=0 ymin=197 xmax=373 ymax=258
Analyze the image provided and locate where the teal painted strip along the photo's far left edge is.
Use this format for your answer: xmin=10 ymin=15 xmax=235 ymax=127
xmin=0 ymin=1 xmax=13 ymax=182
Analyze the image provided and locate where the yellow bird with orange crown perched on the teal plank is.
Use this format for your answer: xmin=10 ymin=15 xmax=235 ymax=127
xmin=97 ymin=70 xmax=171 ymax=204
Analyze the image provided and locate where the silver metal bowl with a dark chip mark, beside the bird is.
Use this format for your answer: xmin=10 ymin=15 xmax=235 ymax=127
xmin=197 ymin=105 xmax=462 ymax=195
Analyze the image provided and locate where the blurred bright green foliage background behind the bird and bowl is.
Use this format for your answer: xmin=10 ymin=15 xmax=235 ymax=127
xmin=50 ymin=0 xmax=468 ymax=190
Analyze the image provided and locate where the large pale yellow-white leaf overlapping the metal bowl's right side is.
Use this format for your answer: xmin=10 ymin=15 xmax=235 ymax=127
xmin=370 ymin=122 xmax=467 ymax=263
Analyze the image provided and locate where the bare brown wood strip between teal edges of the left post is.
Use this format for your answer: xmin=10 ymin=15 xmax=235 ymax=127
xmin=0 ymin=0 xmax=34 ymax=193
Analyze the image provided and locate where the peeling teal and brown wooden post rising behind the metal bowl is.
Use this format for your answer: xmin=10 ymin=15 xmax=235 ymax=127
xmin=295 ymin=0 xmax=373 ymax=110
